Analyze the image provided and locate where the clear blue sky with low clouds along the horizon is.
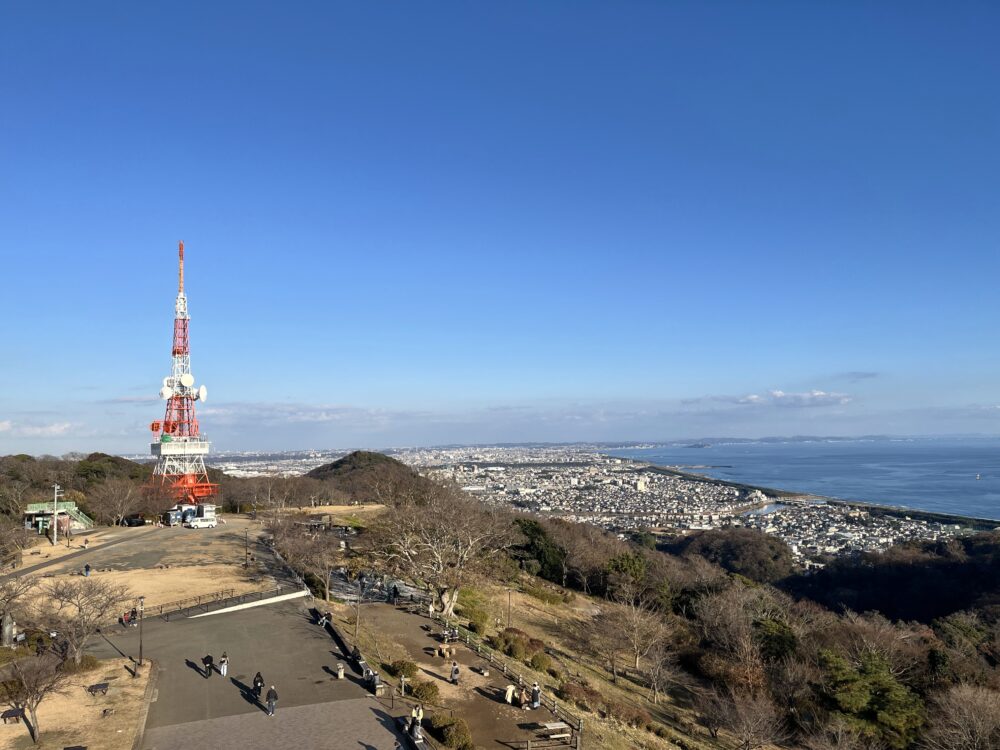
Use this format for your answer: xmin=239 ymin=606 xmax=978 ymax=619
xmin=0 ymin=0 xmax=1000 ymax=453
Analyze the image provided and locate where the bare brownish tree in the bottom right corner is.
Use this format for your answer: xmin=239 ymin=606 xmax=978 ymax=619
xmin=920 ymin=684 xmax=1000 ymax=750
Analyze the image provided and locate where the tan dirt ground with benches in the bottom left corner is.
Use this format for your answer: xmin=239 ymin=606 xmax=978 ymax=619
xmin=0 ymin=659 xmax=150 ymax=750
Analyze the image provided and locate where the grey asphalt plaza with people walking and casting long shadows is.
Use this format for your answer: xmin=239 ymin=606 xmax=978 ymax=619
xmin=90 ymin=600 xmax=406 ymax=750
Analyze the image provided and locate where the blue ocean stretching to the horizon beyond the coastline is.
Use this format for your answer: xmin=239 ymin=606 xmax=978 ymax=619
xmin=609 ymin=438 xmax=1000 ymax=520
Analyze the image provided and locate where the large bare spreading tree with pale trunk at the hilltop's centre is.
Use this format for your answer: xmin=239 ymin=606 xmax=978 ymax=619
xmin=366 ymin=487 xmax=515 ymax=617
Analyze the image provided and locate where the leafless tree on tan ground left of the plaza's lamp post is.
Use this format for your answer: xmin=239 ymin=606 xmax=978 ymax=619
xmin=43 ymin=578 xmax=135 ymax=664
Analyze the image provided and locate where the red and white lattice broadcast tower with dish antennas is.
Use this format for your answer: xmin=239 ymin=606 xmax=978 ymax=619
xmin=149 ymin=242 xmax=219 ymax=503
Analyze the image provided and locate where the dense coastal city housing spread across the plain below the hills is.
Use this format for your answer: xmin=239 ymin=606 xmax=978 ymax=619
xmin=205 ymin=445 xmax=992 ymax=565
